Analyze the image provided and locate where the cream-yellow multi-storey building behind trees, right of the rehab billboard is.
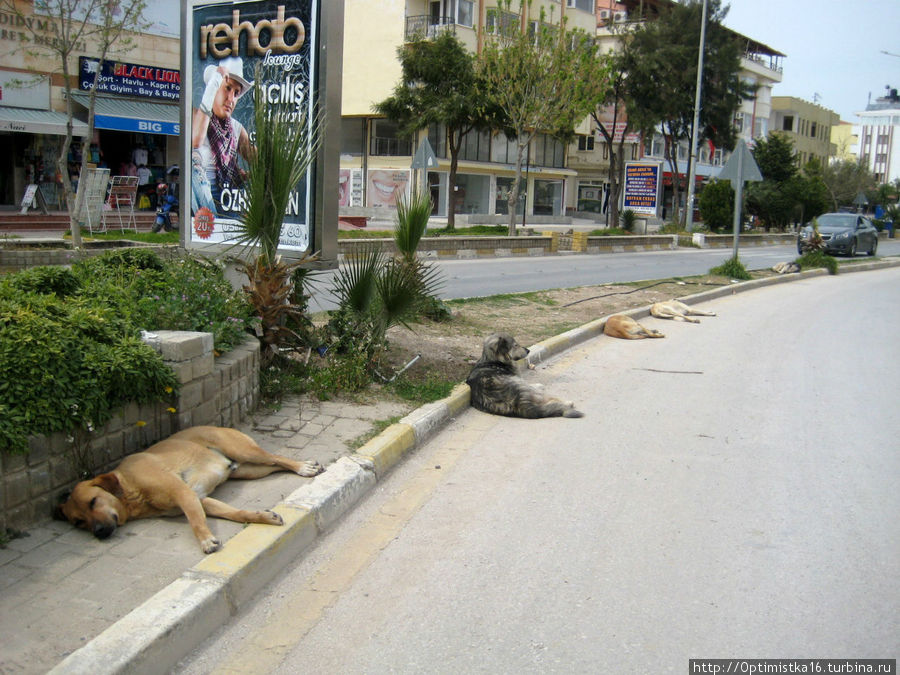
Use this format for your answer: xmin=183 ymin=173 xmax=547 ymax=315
xmin=340 ymin=0 xmax=596 ymax=223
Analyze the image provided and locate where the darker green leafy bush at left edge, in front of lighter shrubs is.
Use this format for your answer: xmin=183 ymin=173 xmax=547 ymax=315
xmin=0 ymin=295 xmax=178 ymax=452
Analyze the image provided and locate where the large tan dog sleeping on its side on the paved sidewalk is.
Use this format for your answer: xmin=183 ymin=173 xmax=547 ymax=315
xmin=56 ymin=427 xmax=322 ymax=553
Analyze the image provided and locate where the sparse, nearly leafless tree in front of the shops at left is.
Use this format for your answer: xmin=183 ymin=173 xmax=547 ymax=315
xmin=0 ymin=0 xmax=147 ymax=247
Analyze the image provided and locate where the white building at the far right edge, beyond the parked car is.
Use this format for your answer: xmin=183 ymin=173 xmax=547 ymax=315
xmin=856 ymin=87 xmax=900 ymax=183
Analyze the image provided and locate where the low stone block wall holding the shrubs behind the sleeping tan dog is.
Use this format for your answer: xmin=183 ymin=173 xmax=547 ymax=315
xmin=0 ymin=331 xmax=259 ymax=533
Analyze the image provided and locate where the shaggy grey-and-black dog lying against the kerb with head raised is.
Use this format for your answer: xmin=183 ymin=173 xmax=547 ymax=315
xmin=466 ymin=333 xmax=584 ymax=419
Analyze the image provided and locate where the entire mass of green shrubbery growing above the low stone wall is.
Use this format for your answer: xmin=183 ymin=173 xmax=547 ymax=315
xmin=0 ymin=249 xmax=249 ymax=452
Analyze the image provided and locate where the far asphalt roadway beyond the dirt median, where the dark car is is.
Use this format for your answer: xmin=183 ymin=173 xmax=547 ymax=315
xmin=311 ymin=239 xmax=900 ymax=311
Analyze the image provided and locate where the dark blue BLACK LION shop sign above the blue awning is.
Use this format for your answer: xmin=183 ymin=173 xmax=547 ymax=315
xmin=78 ymin=56 xmax=181 ymax=101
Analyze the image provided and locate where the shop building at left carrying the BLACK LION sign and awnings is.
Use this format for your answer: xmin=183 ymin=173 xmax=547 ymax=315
xmin=0 ymin=0 xmax=181 ymax=210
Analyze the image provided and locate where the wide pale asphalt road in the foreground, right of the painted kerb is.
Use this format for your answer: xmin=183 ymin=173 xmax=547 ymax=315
xmin=178 ymin=268 xmax=900 ymax=674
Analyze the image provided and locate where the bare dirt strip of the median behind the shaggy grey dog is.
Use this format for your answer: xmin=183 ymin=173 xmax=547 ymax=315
xmin=385 ymin=272 xmax=772 ymax=382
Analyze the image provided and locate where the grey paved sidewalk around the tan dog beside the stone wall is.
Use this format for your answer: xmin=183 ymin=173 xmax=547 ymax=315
xmin=0 ymin=397 xmax=411 ymax=675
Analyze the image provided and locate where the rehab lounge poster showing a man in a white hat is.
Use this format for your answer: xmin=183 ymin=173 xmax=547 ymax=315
xmin=183 ymin=0 xmax=320 ymax=251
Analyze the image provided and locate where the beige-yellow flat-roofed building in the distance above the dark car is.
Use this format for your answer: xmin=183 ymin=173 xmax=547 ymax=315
xmin=771 ymin=96 xmax=841 ymax=168
